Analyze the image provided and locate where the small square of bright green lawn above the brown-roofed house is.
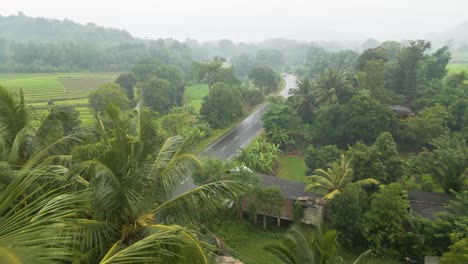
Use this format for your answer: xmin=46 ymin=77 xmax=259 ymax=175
xmin=277 ymin=154 xmax=307 ymax=182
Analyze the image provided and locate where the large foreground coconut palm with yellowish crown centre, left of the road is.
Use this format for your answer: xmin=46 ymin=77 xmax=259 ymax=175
xmin=70 ymin=105 xmax=249 ymax=263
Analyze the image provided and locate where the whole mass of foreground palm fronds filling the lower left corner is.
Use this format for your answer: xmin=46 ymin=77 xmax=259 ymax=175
xmin=0 ymin=86 xmax=250 ymax=263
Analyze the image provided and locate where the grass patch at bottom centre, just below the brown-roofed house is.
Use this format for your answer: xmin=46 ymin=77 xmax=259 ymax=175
xmin=213 ymin=221 xmax=285 ymax=264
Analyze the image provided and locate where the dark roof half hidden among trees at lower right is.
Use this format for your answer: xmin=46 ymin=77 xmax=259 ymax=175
xmin=408 ymin=191 xmax=451 ymax=220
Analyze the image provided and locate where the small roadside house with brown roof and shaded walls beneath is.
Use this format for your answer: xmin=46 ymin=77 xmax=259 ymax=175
xmin=241 ymin=174 xmax=324 ymax=225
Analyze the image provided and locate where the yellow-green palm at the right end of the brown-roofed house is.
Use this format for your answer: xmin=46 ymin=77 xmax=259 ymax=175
xmin=305 ymin=155 xmax=379 ymax=200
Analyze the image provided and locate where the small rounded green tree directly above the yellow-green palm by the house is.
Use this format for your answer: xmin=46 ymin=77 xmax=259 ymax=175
xmin=304 ymin=145 xmax=340 ymax=173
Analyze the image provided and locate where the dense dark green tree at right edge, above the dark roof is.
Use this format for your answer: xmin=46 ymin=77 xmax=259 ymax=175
xmin=408 ymin=136 xmax=468 ymax=192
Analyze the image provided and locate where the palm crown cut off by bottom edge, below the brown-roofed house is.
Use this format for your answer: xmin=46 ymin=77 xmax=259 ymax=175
xmin=265 ymin=223 xmax=370 ymax=264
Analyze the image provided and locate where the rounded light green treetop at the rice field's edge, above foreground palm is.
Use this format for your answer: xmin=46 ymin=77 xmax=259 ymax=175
xmin=88 ymin=83 xmax=130 ymax=113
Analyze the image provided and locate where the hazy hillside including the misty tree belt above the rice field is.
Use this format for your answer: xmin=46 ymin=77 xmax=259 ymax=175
xmin=0 ymin=13 xmax=192 ymax=72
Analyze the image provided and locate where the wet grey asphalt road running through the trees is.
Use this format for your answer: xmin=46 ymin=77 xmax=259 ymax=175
xmin=176 ymin=75 xmax=296 ymax=195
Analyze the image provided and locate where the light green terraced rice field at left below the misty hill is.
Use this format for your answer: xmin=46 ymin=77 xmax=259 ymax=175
xmin=0 ymin=73 xmax=118 ymax=124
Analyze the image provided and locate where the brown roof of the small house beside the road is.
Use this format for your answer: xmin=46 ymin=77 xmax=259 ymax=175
xmin=259 ymin=174 xmax=321 ymax=200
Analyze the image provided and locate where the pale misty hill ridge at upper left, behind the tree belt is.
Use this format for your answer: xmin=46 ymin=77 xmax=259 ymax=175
xmin=0 ymin=13 xmax=133 ymax=42
